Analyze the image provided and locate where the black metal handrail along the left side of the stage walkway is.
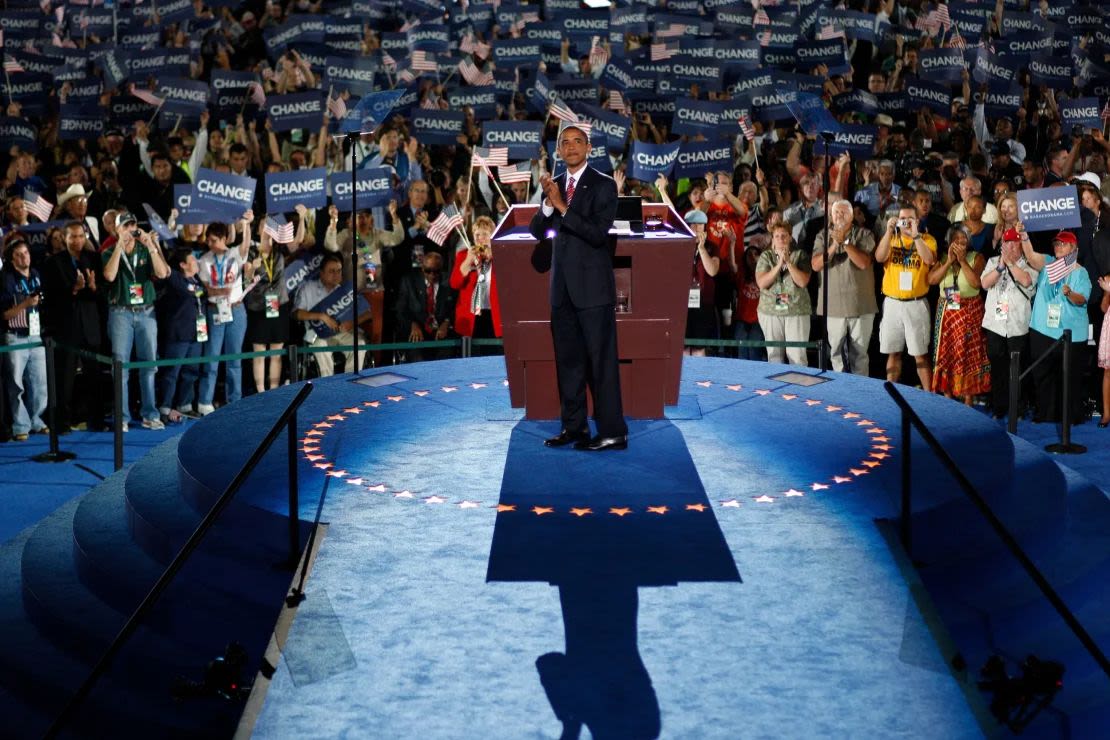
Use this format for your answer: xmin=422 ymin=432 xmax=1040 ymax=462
xmin=43 ymin=382 xmax=313 ymax=738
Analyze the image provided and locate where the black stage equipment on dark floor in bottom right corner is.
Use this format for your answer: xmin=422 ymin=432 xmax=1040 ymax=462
xmin=979 ymin=656 xmax=1064 ymax=734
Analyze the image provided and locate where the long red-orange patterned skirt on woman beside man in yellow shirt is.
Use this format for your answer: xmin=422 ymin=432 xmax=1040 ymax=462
xmin=932 ymin=295 xmax=990 ymax=397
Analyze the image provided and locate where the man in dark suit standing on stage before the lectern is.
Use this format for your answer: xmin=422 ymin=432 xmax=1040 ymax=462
xmin=529 ymin=124 xmax=628 ymax=450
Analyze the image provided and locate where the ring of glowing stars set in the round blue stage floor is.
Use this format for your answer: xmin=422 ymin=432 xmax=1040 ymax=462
xmin=299 ymin=379 xmax=895 ymax=519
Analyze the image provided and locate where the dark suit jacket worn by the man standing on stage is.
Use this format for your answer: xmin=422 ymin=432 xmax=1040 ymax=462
xmin=528 ymin=165 xmax=617 ymax=308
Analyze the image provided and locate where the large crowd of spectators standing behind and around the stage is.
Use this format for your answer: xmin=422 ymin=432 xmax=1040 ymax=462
xmin=0 ymin=0 xmax=1110 ymax=439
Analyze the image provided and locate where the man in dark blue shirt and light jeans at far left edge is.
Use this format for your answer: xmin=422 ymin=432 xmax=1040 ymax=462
xmin=0 ymin=236 xmax=48 ymax=442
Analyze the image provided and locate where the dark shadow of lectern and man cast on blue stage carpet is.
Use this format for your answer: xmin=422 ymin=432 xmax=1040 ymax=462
xmin=486 ymin=422 xmax=740 ymax=738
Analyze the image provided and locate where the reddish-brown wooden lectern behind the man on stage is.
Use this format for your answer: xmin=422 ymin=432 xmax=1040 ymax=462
xmin=493 ymin=203 xmax=695 ymax=419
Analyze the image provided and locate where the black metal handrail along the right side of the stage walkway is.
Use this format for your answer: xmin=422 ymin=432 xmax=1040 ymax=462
xmin=882 ymin=381 xmax=1110 ymax=678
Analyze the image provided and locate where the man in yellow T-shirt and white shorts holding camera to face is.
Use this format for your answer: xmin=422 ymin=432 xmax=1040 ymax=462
xmin=875 ymin=206 xmax=937 ymax=391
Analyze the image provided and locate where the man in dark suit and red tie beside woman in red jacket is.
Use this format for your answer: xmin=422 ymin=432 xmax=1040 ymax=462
xmin=397 ymin=252 xmax=455 ymax=362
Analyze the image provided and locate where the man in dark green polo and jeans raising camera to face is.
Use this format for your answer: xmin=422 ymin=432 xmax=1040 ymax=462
xmin=102 ymin=211 xmax=170 ymax=432
